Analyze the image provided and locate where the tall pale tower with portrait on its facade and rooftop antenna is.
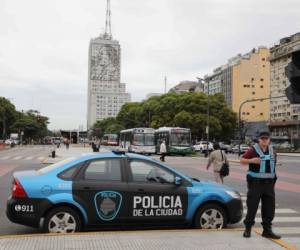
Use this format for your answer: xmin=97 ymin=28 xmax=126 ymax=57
xmin=87 ymin=0 xmax=130 ymax=129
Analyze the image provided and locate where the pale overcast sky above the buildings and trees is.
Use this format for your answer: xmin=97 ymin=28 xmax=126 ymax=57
xmin=0 ymin=0 xmax=300 ymax=129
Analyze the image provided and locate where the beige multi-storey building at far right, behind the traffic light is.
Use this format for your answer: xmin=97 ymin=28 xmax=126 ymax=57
xmin=269 ymin=33 xmax=300 ymax=146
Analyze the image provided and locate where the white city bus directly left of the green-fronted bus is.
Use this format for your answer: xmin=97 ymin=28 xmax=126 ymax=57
xmin=120 ymin=128 xmax=155 ymax=155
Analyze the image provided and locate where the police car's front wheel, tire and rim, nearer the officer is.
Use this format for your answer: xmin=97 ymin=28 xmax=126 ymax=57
xmin=194 ymin=204 xmax=227 ymax=229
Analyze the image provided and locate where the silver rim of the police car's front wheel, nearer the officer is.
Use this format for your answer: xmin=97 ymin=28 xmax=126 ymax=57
xmin=200 ymin=209 xmax=224 ymax=229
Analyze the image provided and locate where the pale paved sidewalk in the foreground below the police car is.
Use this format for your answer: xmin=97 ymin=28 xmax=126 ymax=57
xmin=0 ymin=229 xmax=296 ymax=250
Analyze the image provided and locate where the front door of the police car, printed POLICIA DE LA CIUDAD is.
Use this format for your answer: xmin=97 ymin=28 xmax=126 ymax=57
xmin=127 ymin=159 xmax=188 ymax=223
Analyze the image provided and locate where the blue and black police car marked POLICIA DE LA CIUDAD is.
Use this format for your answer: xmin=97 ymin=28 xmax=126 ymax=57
xmin=6 ymin=152 xmax=243 ymax=233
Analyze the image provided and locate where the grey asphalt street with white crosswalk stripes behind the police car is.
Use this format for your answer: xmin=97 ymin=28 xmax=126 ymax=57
xmin=0 ymin=146 xmax=300 ymax=246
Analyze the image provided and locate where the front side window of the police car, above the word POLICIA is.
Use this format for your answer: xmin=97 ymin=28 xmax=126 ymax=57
xmin=130 ymin=161 xmax=175 ymax=183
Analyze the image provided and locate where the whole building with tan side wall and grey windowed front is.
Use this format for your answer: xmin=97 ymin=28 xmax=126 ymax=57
xmin=204 ymin=47 xmax=270 ymax=122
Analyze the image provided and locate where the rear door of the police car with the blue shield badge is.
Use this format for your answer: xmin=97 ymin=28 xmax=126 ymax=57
xmin=73 ymin=158 xmax=128 ymax=225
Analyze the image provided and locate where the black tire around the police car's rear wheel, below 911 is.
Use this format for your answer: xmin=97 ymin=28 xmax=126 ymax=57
xmin=43 ymin=206 xmax=82 ymax=233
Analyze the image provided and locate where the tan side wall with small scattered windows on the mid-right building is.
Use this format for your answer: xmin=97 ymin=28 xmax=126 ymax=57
xmin=232 ymin=47 xmax=270 ymax=122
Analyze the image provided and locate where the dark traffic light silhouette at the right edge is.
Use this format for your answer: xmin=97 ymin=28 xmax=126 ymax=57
xmin=285 ymin=46 xmax=300 ymax=104
